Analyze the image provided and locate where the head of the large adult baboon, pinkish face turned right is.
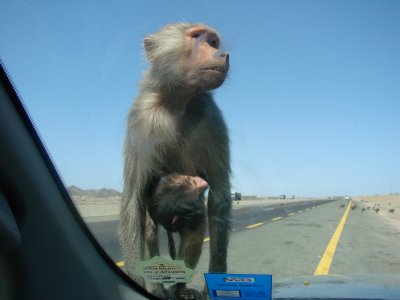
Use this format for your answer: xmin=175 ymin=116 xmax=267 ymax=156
xmin=144 ymin=24 xmax=229 ymax=95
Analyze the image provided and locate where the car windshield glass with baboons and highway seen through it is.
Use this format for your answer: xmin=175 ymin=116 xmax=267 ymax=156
xmin=0 ymin=0 xmax=400 ymax=299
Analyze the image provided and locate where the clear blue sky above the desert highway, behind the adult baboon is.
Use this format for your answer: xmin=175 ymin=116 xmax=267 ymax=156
xmin=0 ymin=0 xmax=400 ymax=196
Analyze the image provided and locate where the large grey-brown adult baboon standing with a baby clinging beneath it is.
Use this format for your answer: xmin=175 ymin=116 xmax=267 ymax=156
xmin=121 ymin=23 xmax=231 ymax=296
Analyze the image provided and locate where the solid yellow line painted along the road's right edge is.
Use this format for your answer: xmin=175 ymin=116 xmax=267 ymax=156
xmin=314 ymin=202 xmax=351 ymax=275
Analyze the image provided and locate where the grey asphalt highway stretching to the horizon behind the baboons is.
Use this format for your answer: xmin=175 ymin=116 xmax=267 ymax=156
xmin=83 ymin=200 xmax=400 ymax=290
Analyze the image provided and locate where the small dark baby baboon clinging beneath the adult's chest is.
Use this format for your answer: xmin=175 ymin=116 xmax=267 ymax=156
xmin=147 ymin=173 xmax=208 ymax=259
